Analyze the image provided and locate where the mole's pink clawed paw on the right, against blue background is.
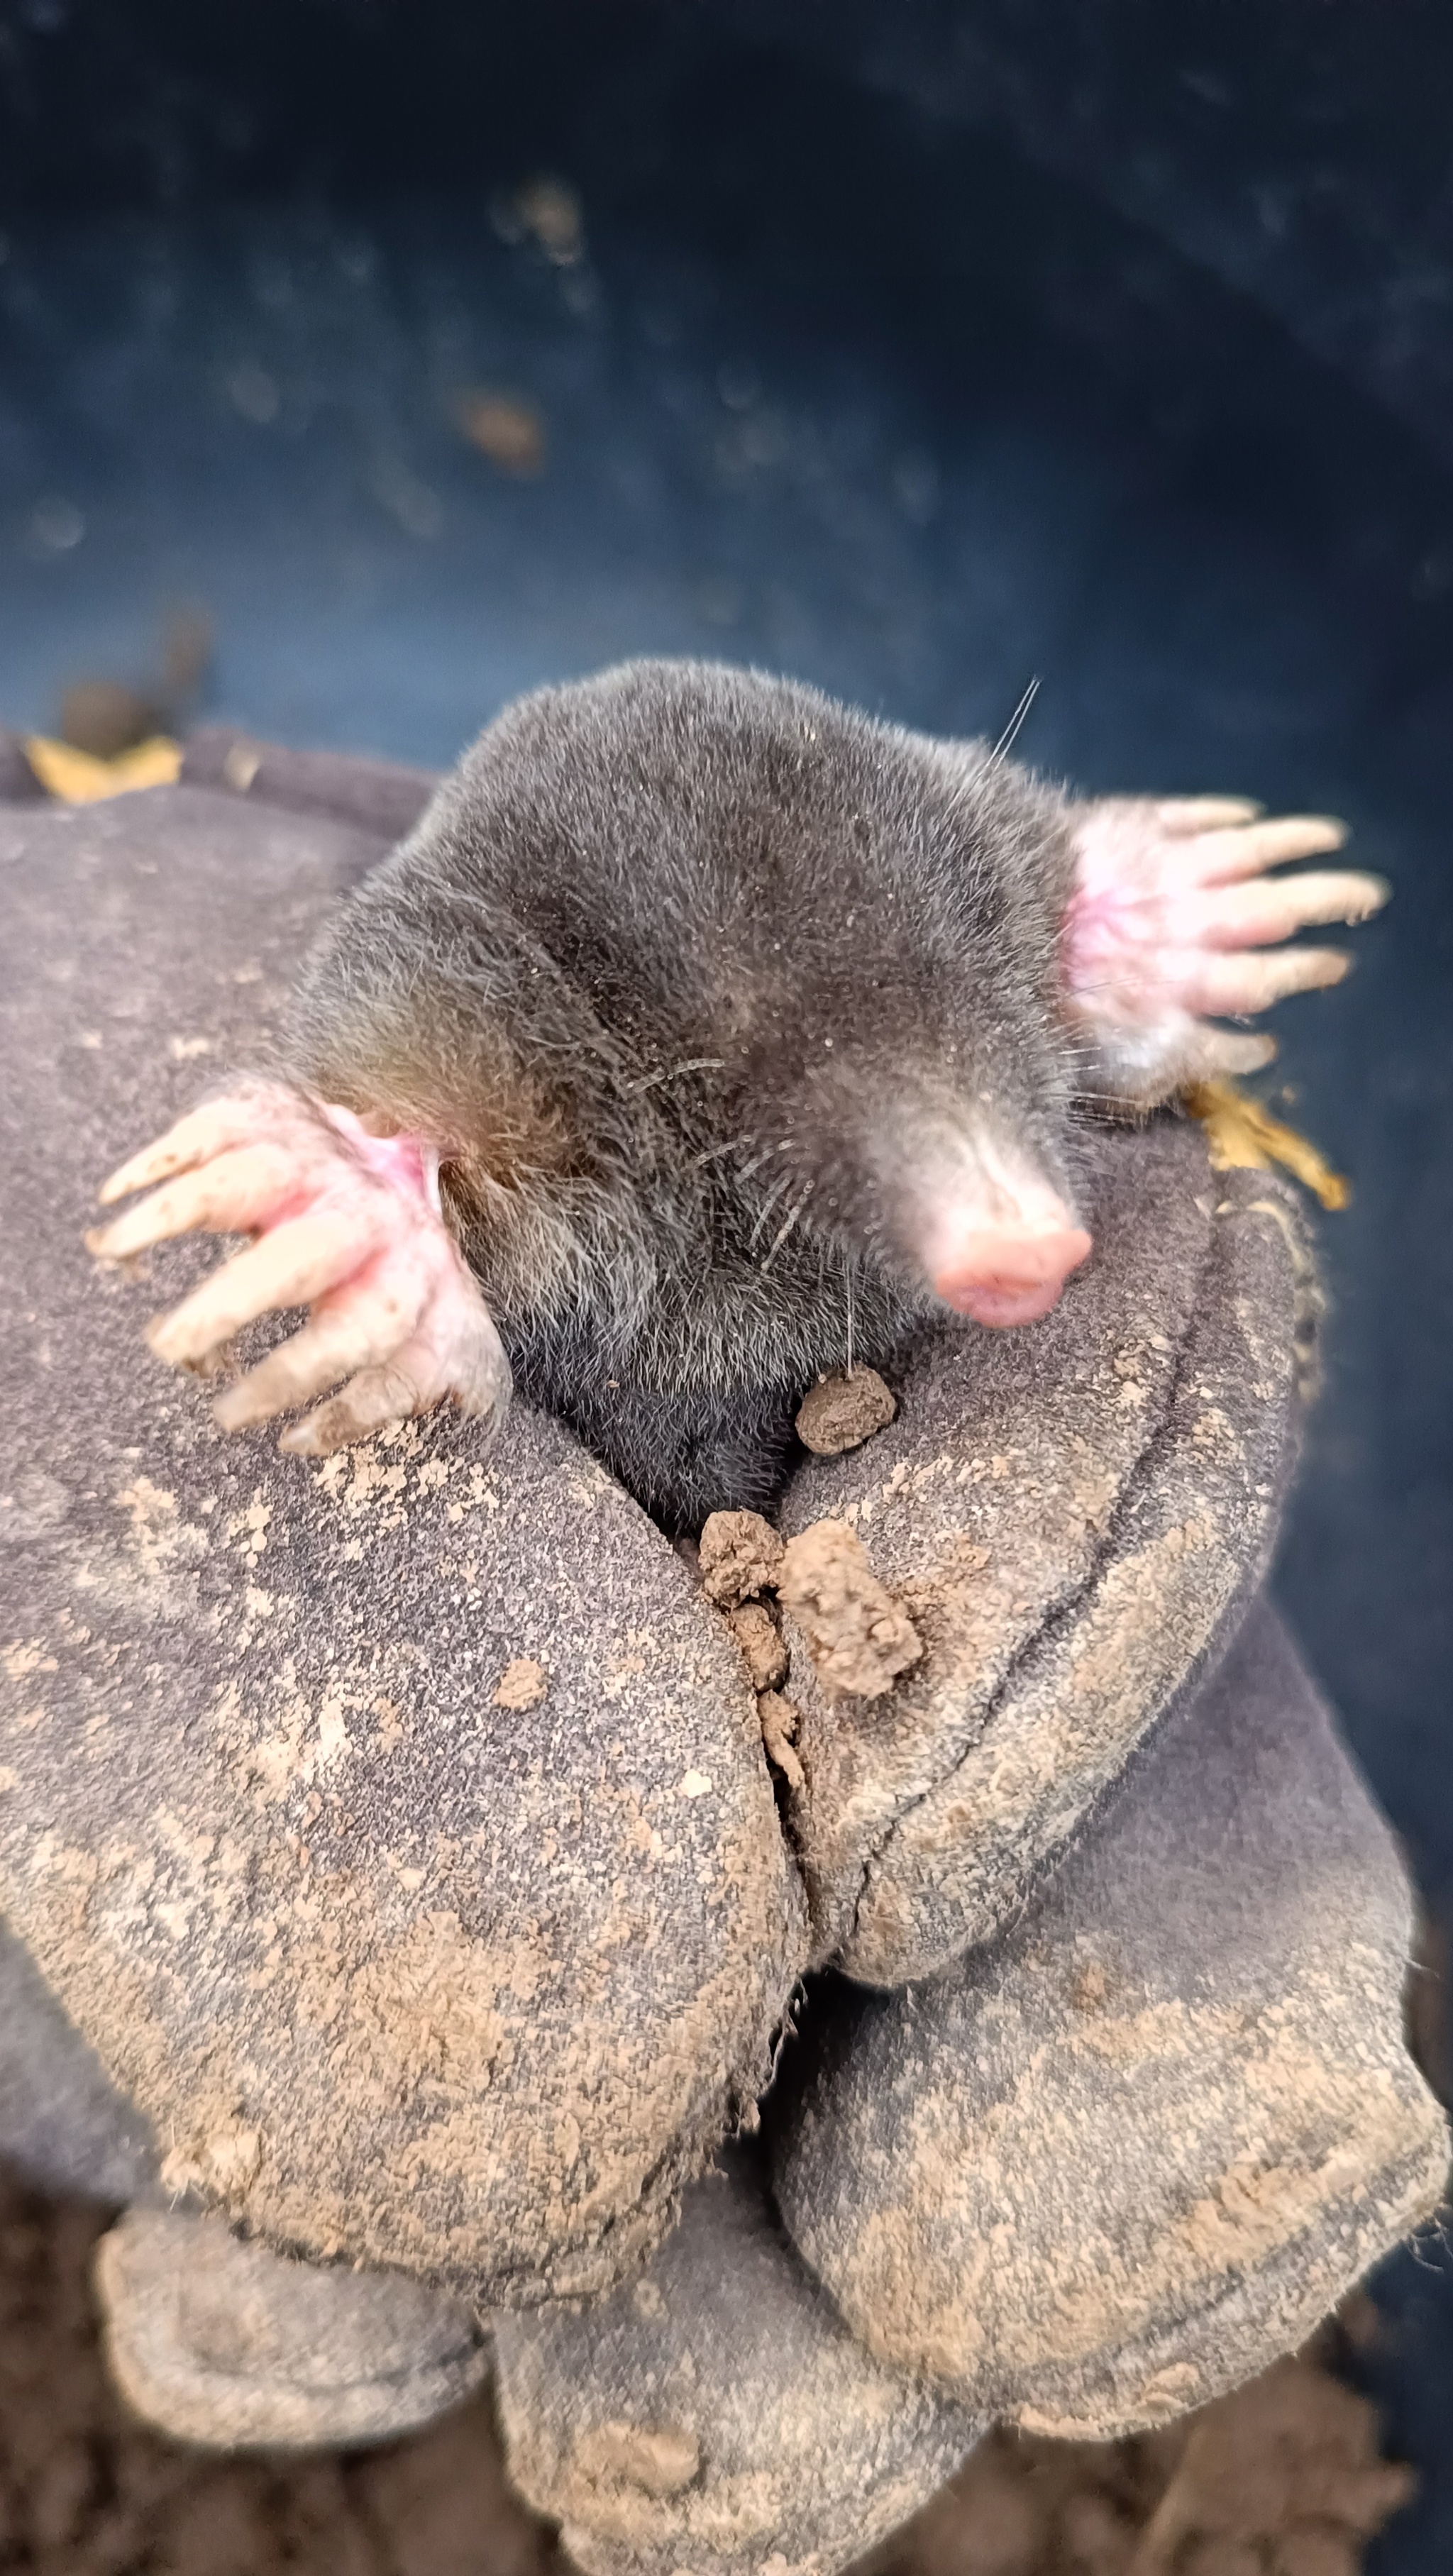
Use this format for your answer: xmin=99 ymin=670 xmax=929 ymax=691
xmin=1061 ymin=796 xmax=1391 ymax=1107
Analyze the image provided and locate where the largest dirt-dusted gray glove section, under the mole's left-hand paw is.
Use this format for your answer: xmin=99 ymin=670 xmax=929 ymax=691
xmin=0 ymin=770 xmax=807 ymax=2306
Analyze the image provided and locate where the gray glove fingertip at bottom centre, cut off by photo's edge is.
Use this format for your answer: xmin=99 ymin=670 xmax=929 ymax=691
xmin=497 ymin=2148 xmax=984 ymax=2576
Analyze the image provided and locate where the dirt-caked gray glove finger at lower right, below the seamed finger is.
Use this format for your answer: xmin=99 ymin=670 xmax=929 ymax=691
xmin=770 ymin=1602 xmax=1448 ymax=2437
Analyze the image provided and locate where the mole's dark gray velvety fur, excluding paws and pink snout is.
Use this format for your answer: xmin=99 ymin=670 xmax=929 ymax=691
xmin=291 ymin=662 xmax=1074 ymax=1530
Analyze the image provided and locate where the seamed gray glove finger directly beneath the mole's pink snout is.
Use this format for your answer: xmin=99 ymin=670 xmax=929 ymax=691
xmin=780 ymin=1120 xmax=1317 ymax=1986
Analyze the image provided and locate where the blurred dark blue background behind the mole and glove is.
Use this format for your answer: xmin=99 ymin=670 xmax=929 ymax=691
xmin=0 ymin=0 xmax=1453 ymax=2576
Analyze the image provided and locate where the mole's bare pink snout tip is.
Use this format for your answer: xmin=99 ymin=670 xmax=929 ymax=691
xmin=910 ymin=1139 xmax=1090 ymax=1327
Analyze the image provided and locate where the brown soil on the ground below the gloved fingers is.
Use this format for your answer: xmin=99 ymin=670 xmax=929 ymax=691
xmin=0 ymin=2172 xmax=1415 ymax=2576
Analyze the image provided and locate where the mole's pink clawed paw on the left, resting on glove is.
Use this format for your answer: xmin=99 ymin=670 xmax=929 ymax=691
xmin=87 ymin=1082 xmax=510 ymax=1456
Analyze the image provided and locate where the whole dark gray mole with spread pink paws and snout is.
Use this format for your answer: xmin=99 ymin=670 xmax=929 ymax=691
xmin=87 ymin=660 xmax=1388 ymax=1535
